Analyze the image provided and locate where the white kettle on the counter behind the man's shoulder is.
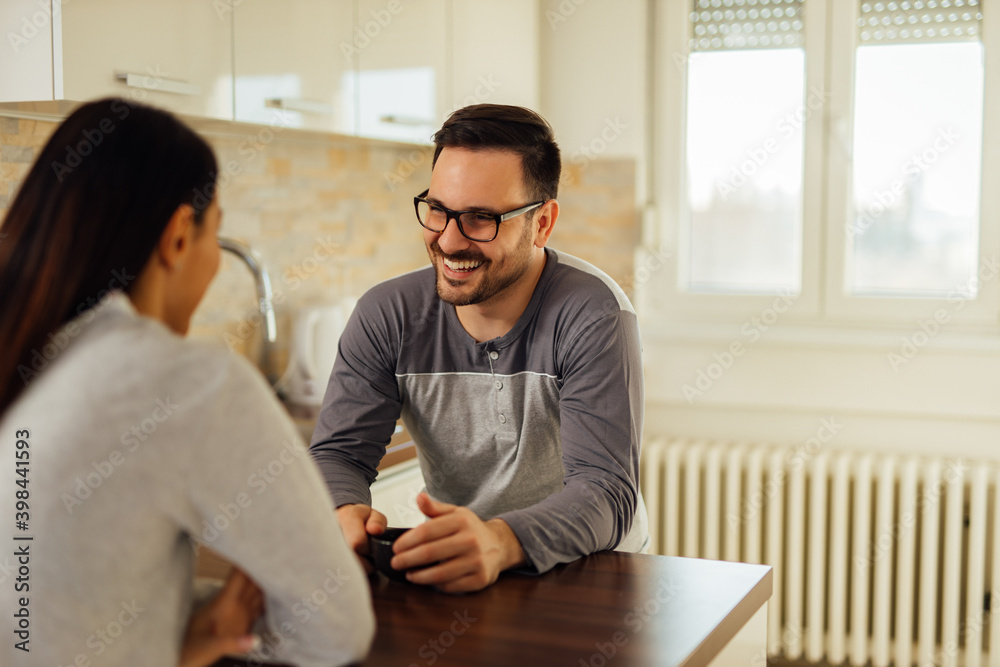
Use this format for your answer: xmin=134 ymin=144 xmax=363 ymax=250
xmin=277 ymin=298 xmax=356 ymax=418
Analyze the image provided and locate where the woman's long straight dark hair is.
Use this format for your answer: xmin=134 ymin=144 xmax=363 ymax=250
xmin=0 ymin=99 xmax=218 ymax=416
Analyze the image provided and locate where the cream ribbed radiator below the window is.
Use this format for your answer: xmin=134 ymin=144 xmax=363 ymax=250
xmin=640 ymin=440 xmax=1000 ymax=667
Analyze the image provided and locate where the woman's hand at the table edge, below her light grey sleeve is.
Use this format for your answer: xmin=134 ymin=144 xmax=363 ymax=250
xmin=180 ymin=569 xmax=264 ymax=667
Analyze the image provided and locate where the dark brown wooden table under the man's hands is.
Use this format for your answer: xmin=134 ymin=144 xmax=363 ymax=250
xmin=215 ymin=552 xmax=771 ymax=667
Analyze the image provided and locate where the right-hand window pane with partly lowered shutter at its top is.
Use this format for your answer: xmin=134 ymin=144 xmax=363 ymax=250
xmin=847 ymin=0 xmax=983 ymax=297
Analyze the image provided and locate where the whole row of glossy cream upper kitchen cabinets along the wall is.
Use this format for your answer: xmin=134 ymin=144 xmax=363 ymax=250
xmin=0 ymin=0 xmax=540 ymax=143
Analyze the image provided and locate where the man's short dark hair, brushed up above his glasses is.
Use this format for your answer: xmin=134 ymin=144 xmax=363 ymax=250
xmin=431 ymin=104 xmax=562 ymax=202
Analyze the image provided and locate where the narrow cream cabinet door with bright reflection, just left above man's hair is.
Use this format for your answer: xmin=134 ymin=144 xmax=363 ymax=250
xmin=353 ymin=0 xmax=450 ymax=144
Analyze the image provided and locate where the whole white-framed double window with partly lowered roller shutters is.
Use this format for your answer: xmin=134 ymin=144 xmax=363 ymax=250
xmin=652 ymin=0 xmax=1000 ymax=325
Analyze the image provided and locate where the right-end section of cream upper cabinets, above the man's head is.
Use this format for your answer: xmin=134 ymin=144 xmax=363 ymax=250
xmin=354 ymin=0 xmax=539 ymax=143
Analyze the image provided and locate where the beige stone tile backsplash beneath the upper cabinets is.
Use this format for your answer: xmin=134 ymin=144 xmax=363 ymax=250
xmin=0 ymin=112 xmax=640 ymax=378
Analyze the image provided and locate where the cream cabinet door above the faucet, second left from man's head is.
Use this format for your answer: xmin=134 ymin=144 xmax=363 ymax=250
xmin=233 ymin=0 xmax=356 ymax=134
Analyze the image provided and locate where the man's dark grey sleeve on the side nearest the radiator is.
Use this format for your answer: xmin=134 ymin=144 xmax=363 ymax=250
xmin=500 ymin=309 xmax=643 ymax=572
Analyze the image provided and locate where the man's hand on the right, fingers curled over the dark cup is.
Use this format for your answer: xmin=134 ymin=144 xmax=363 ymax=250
xmin=392 ymin=493 xmax=525 ymax=593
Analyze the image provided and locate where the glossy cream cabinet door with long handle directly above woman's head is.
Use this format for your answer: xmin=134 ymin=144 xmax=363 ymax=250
xmin=60 ymin=0 xmax=233 ymax=120
